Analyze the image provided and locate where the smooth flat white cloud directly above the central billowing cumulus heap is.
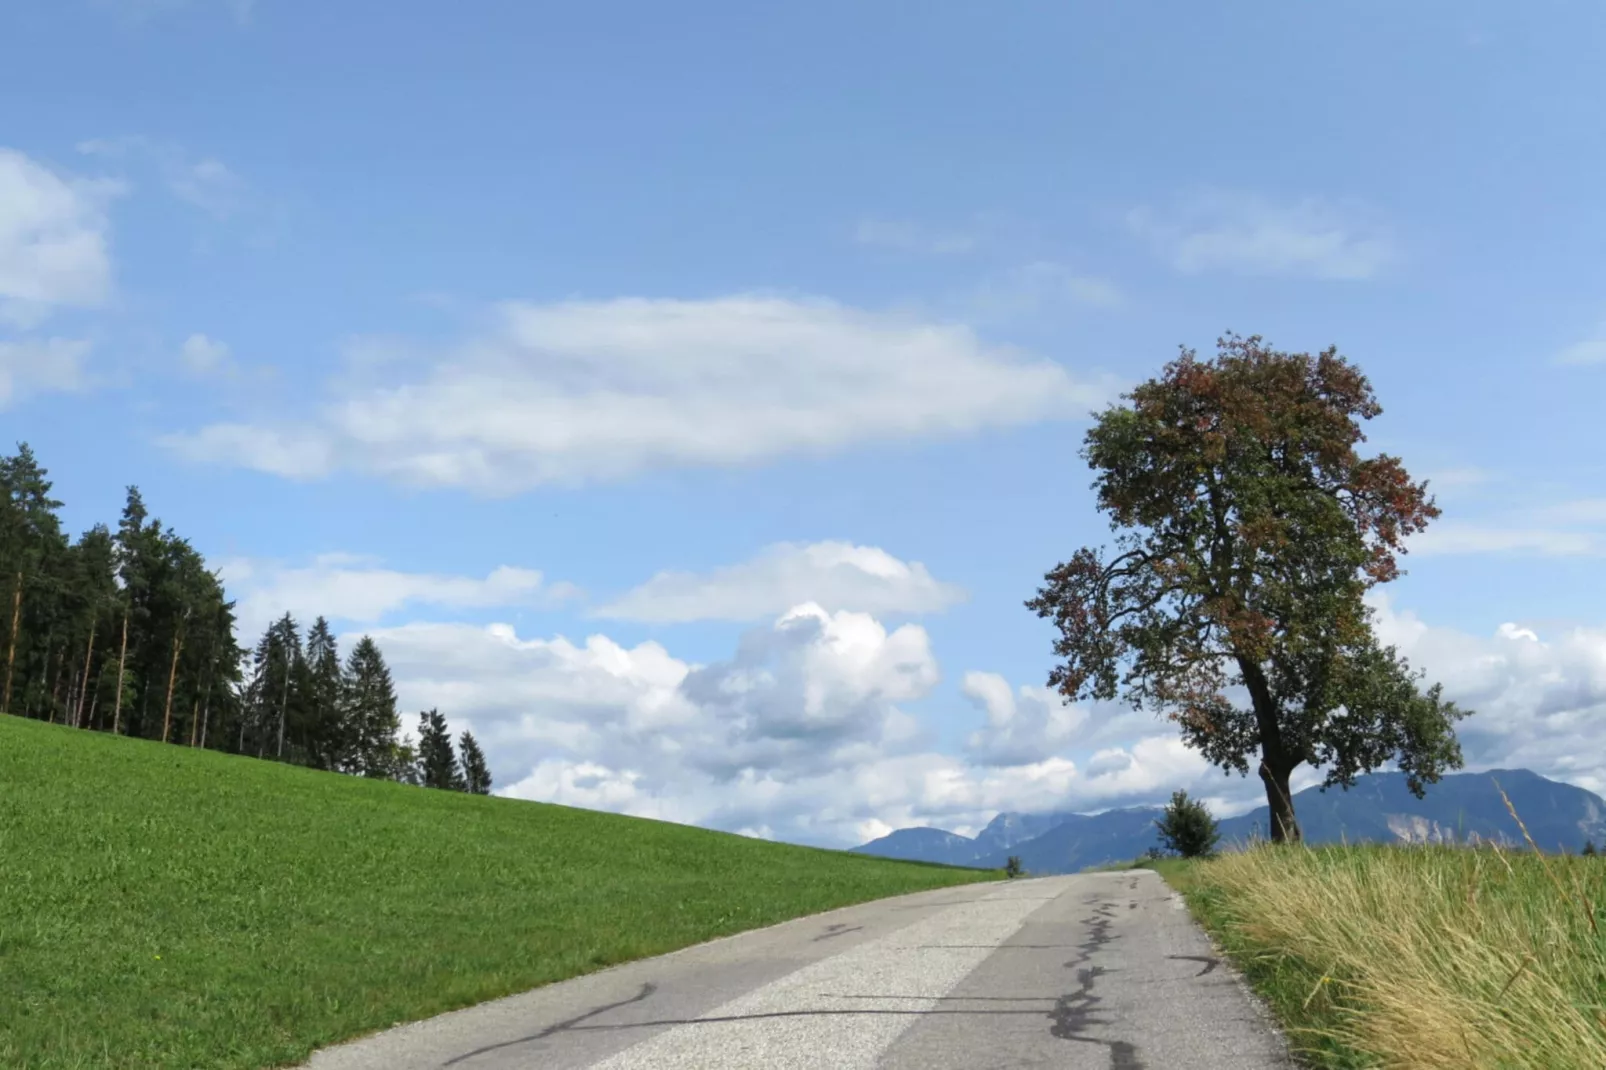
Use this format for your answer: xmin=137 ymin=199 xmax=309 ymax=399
xmin=594 ymin=541 xmax=965 ymax=623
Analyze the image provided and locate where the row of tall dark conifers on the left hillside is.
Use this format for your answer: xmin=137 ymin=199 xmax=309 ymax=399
xmin=0 ymin=443 xmax=491 ymax=794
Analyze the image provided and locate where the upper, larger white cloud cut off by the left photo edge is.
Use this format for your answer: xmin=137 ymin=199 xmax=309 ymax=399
xmin=0 ymin=148 xmax=120 ymax=328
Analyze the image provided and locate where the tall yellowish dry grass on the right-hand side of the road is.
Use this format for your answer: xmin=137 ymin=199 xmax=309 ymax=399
xmin=1156 ymin=845 xmax=1606 ymax=1070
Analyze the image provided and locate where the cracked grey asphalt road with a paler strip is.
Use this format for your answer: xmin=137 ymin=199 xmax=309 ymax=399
xmin=307 ymin=871 xmax=1291 ymax=1070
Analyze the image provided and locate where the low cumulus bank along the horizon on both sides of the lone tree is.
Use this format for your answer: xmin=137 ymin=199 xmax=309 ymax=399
xmin=322 ymin=578 xmax=1606 ymax=847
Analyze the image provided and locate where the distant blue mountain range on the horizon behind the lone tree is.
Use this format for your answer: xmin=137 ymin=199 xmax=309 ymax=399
xmin=853 ymin=770 xmax=1606 ymax=874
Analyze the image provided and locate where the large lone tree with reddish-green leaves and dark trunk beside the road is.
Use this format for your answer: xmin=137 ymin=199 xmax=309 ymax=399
xmin=1026 ymin=334 xmax=1466 ymax=840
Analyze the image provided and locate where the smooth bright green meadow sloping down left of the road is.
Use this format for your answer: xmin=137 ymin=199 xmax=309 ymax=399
xmin=0 ymin=706 xmax=1001 ymax=1070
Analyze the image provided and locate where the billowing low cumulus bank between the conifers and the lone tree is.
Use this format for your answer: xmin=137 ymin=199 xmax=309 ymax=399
xmin=351 ymin=604 xmax=1226 ymax=847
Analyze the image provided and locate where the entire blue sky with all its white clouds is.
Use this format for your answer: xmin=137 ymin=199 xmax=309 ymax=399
xmin=0 ymin=0 xmax=1606 ymax=847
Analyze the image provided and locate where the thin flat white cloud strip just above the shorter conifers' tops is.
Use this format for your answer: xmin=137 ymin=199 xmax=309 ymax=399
xmin=220 ymin=554 xmax=577 ymax=636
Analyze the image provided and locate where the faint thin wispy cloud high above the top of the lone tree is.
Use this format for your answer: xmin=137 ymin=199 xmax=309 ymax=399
xmin=1127 ymin=193 xmax=1396 ymax=280
